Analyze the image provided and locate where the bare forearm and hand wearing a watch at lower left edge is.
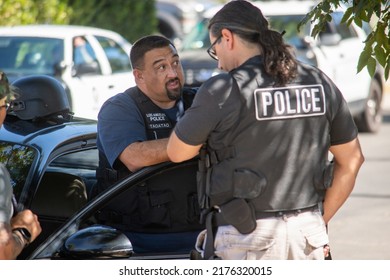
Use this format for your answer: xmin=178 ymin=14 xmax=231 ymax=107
xmin=0 ymin=210 xmax=42 ymax=260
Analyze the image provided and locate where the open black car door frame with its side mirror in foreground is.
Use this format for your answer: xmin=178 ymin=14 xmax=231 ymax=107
xmin=27 ymin=160 xmax=197 ymax=259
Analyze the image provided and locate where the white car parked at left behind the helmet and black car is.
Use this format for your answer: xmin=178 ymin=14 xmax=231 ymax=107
xmin=0 ymin=25 xmax=135 ymax=119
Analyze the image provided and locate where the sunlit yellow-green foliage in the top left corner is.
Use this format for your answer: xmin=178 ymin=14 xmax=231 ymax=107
xmin=0 ymin=0 xmax=70 ymax=26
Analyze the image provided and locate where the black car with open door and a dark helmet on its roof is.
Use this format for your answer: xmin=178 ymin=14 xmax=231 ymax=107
xmin=0 ymin=76 xmax=201 ymax=259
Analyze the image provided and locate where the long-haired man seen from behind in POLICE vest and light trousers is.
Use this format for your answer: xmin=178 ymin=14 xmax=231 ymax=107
xmin=167 ymin=0 xmax=364 ymax=259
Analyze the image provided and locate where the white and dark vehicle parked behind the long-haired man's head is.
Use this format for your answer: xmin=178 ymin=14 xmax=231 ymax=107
xmin=179 ymin=1 xmax=384 ymax=132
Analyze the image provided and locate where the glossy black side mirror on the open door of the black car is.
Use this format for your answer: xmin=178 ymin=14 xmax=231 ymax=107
xmin=59 ymin=225 xmax=133 ymax=260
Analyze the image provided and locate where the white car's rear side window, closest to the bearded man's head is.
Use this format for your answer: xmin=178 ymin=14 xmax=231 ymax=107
xmin=96 ymin=36 xmax=131 ymax=73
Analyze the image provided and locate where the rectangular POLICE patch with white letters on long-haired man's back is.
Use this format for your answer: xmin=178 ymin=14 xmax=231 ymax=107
xmin=254 ymin=85 xmax=326 ymax=121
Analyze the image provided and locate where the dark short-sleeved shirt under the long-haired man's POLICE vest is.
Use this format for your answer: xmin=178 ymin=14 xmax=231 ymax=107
xmin=175 ymin=57 xmax=357 ymax=149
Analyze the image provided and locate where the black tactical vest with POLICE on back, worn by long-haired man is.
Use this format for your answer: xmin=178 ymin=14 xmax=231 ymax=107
xmin=198 ymin=62 xmax=332 ymax=212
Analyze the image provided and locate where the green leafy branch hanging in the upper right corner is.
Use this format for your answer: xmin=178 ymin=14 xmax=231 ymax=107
xmin=299 ymin=0 xmax=390 ymax=80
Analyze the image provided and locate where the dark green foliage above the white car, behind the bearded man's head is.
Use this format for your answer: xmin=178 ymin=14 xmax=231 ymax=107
xmin=68 ymin=0 xmax=157 ymax=42
